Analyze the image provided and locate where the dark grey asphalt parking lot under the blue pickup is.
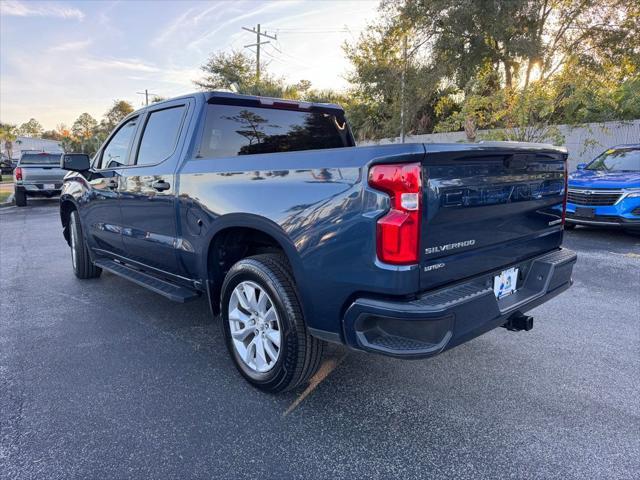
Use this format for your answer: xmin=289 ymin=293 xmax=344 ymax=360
xmin=0 ymin=200 xmax=640 ymax=480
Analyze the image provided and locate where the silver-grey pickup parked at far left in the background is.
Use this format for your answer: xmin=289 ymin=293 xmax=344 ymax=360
xmin=13 ymin=152 xmax=67 ymax=207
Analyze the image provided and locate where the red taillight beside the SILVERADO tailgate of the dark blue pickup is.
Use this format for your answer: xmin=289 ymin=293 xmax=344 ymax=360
xmin=369 ymin=163 xmax=422 ymax=265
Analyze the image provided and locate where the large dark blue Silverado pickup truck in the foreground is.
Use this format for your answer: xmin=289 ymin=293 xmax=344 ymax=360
xmin=60 ymin=92 xmax=576 ymax=392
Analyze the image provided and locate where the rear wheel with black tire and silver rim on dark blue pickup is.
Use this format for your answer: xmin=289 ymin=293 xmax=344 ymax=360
xmin=220 ymin=254 xmax=324 ymax=393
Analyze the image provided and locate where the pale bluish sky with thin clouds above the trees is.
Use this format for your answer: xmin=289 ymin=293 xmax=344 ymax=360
xmin=0 ymin=0 xmax=378 ymax=129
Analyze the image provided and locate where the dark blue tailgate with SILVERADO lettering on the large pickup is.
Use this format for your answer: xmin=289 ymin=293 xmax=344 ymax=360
xmin=420 ymin=142 xmax=566 ymax=289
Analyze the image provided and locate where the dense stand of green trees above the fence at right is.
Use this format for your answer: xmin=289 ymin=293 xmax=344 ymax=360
xmin=345 ymin=0 xmax=640 ymax=141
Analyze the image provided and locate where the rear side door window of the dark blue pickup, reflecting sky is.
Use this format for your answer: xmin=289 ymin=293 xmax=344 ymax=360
xmin=136 ymin=105 xmax=186 ymax=165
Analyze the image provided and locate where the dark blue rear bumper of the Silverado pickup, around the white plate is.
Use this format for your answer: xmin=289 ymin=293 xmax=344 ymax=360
xmin=343 ymin=249 xmax=577 ymax=358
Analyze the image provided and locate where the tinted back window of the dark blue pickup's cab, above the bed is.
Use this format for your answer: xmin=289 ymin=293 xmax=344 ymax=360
xmin=200 ymin=104 xmax=353 ymax=157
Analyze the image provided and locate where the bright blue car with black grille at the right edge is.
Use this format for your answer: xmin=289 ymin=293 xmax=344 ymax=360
xmin=566 ymin=144 xmax=640 ymax=231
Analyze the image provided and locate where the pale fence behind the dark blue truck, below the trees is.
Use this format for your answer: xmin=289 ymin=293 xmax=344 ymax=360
xmin=361 ymin=120 xmax=640 ymax=171
